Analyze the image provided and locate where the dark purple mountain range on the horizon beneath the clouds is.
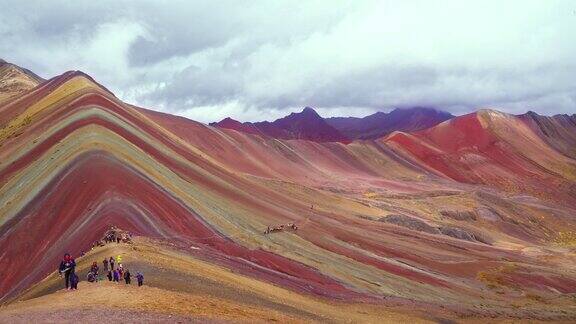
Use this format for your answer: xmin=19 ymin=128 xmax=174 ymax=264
xmin=210 ymin=107 xmax=454 ymax=143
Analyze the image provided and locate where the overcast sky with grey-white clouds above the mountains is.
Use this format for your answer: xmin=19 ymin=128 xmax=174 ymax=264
xmin=0 ymin=0 xmax=576 ymax=122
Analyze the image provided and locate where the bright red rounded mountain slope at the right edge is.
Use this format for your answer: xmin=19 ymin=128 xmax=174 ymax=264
xmin=385 ymin=110 xmax=576 ymax=202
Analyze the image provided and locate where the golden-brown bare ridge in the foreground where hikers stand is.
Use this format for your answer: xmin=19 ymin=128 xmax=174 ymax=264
xmin=0 ymin=238 xmax=438 ymax=323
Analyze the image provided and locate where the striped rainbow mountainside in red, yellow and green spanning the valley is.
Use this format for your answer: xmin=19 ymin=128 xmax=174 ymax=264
xmin=0 ymin=62 xmax=576 ymax=321
